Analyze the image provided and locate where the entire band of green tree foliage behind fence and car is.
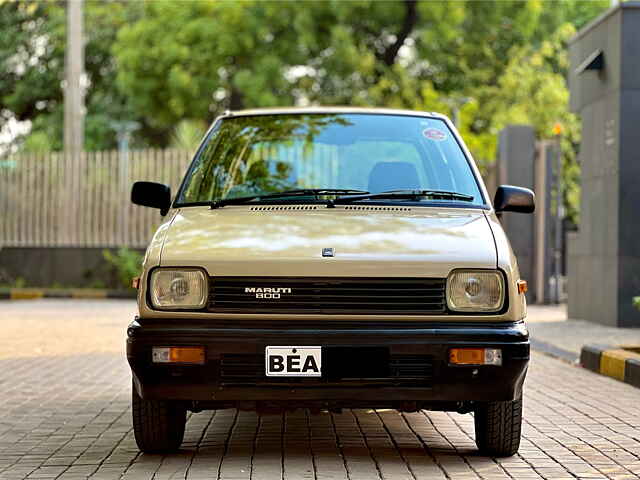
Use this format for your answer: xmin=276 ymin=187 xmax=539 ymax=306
xmin=0 ymin=0 xmax=609 ymax=219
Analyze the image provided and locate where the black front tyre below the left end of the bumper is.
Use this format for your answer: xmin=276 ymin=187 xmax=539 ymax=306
xmin=131 ymin=380 xmax=187 ymax=453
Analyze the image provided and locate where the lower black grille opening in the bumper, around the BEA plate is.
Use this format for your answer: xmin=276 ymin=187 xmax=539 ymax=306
xmin=219 ymin=347 xmax=433 ymax=387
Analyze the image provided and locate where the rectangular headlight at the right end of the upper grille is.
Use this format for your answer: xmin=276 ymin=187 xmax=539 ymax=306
xmin=447 ymin=270 xmax=504 ymax=312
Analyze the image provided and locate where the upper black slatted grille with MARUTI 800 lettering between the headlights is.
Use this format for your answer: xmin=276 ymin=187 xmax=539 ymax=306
xmin=208 ymin=277 xmax=445 ymax=315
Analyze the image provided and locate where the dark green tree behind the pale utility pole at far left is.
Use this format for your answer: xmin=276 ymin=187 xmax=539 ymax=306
xmin=0 ymin=0 xmax=144 ymax=150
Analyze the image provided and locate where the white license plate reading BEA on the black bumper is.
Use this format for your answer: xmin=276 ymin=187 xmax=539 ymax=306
xmin=265 ymin=346 xmax=322 ymax=377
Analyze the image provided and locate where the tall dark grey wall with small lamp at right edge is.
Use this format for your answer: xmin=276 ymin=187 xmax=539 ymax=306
xmin=569 ymin=2 xmax=640 ymax=327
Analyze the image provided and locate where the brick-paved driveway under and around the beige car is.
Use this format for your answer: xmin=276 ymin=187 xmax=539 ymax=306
xmin=0 ymin=301 xmax=640 ymax=480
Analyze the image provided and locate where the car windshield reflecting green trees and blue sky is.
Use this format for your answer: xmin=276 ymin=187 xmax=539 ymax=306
xmin=176 ymin=113 xmax=484 ymax=206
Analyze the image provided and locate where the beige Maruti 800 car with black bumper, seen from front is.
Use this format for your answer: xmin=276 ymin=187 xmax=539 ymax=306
xmin=127 ymin=108 xmax=534 ymax=456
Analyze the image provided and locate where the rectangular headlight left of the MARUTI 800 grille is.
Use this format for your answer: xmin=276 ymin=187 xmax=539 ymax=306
xmin=149 ymin=268 xmax=208 ymax=310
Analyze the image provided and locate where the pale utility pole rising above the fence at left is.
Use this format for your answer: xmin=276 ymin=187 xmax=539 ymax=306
xmin=64 ymin=0 xmax=85 ymax=155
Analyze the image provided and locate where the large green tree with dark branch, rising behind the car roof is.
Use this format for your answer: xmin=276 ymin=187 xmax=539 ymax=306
xmin=113 ymin=0 xmax=606 ymax=150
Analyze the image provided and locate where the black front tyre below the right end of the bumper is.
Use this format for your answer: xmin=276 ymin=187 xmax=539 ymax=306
xmin=474 ymin=397 xmax=522 ymax=457
